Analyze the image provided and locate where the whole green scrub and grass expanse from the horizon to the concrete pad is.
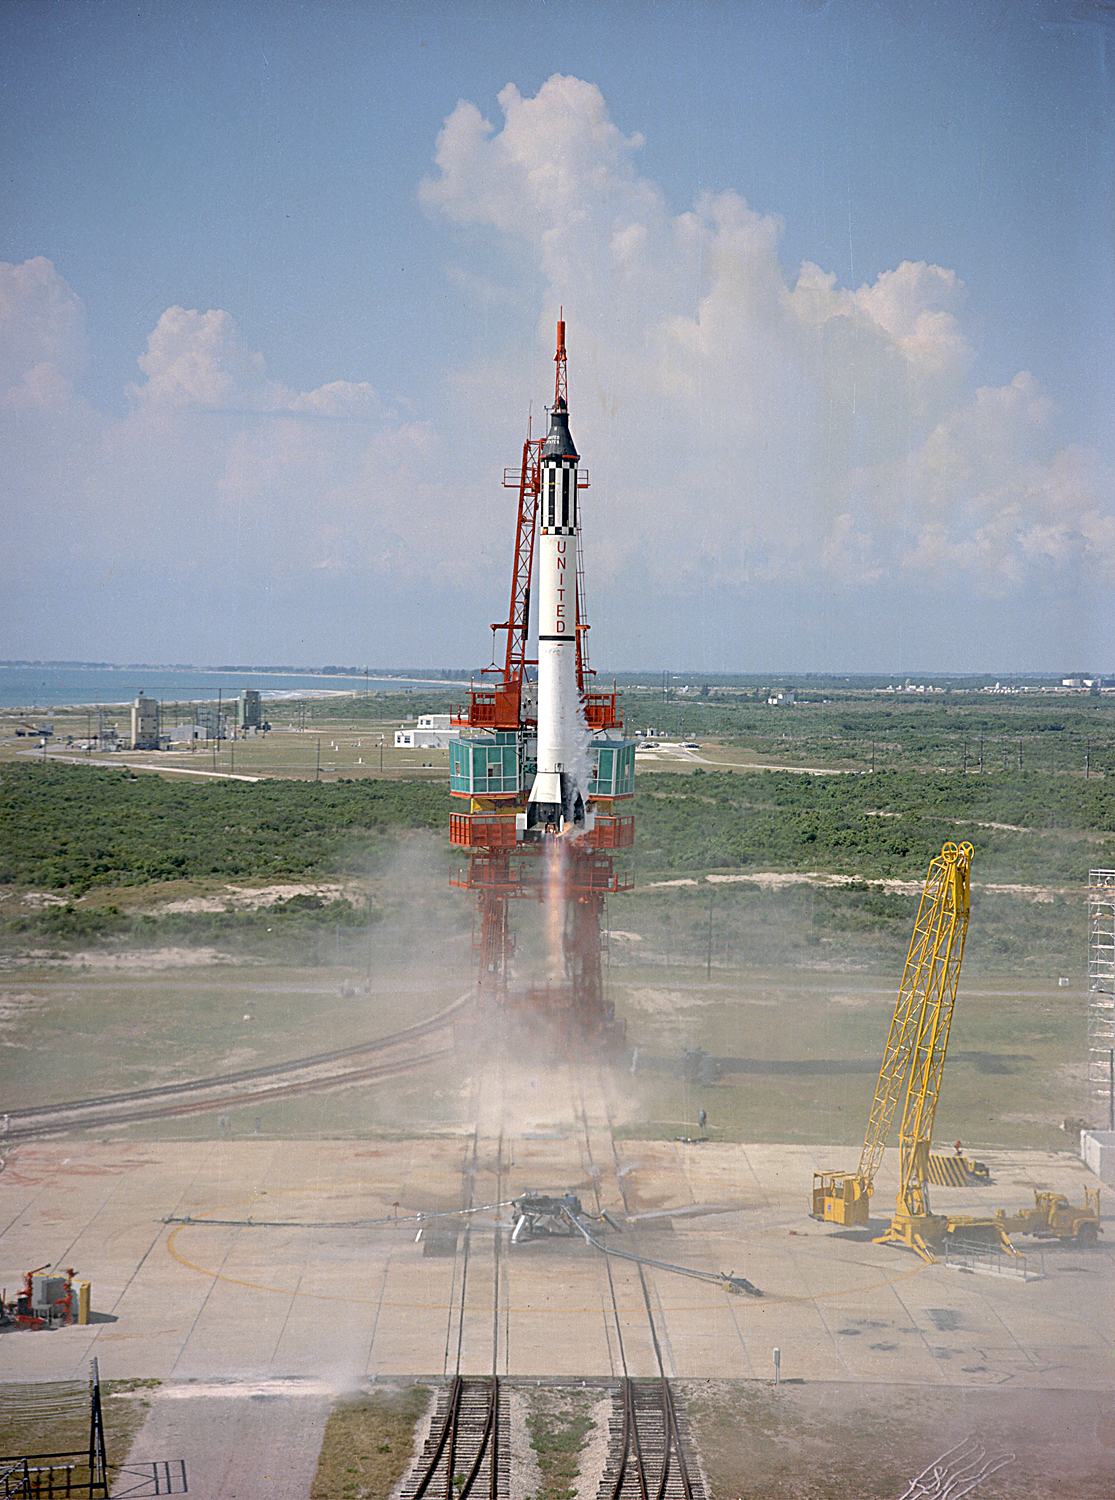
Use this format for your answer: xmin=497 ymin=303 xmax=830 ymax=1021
xmin=0 ymin=692 xmax=1115 ymax=1149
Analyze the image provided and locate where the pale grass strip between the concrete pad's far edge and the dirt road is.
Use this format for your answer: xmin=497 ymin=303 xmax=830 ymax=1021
xmin=0 ymin=965 xmax=1083 ymax=1151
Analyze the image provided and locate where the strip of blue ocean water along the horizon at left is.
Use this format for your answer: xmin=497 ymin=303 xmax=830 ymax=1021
xmin=0 ymin=662 xmax=462 ymax=711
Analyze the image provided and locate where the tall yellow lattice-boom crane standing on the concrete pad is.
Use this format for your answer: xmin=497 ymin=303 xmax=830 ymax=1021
xmin=812 ymin=843 xmax=1011 ymax=1260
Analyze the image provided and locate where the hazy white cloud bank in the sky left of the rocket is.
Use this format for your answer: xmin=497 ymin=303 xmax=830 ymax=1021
xmin=0 ymin=261 xmax=462 ymax=636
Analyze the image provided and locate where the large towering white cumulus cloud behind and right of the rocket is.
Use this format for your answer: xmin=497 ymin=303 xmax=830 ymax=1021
xmin=420 ymin=75 xmax=1115 ymax=621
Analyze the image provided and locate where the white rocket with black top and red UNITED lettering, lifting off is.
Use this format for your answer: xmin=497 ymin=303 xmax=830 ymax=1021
xmin=527 ymin=323 xmax=591 ymax=837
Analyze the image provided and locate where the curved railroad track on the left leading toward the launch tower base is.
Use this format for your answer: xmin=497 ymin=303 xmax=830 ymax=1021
xmin=0 ymin=996 xmax=471 ymax=1146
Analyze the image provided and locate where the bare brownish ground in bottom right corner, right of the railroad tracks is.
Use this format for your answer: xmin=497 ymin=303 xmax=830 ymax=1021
xmin=683 ymin=1380 xmax=1115 ymax=1500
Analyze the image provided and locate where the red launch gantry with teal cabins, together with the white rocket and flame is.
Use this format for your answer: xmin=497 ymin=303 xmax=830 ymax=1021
xmin=449 ymin=321 xmax=635 ymax=1053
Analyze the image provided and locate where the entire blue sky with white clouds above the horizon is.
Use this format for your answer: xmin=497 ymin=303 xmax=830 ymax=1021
xmin=0 ymin=0 xmax=1115 ymax=672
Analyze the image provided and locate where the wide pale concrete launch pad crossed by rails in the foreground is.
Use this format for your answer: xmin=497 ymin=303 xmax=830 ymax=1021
xmin=0 ymin=1124 xmax=1115 ymax=1391
